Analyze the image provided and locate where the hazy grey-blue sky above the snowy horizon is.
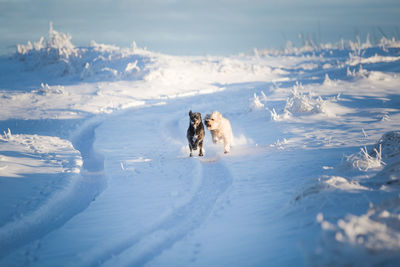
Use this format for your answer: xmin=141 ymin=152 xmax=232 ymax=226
xmin=0 ymin=0 xmax=400 ymax=55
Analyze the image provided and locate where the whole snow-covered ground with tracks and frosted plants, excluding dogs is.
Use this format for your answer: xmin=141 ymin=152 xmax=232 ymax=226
xmin=0 ymin=27 xmax=400 ymax=266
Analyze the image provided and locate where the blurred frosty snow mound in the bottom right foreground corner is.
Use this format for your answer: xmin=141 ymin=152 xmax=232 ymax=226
xmin=313 ymin=202 xmax=400 ymax=266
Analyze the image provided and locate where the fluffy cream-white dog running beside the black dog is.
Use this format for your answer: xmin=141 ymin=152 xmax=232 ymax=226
xmin=204 ymin=111 xmax=233 ymax=154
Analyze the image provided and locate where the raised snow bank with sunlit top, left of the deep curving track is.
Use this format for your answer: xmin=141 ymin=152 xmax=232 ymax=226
xmin=0 ymin=129 xmax=86 ymax=260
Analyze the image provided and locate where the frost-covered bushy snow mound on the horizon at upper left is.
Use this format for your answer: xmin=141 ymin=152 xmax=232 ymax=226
xmin=14 ymin=23 xmax=150 ymax=81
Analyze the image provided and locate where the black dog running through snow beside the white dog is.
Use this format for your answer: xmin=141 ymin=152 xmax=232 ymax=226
xmin=186 ymin=111 xmax=205 ymax=157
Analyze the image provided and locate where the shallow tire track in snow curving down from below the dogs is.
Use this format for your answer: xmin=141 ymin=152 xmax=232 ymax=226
xmin=105 ymin=159 xmax=232 ymax=266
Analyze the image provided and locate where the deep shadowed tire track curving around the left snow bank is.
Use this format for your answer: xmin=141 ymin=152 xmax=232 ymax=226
xmin=0 ymin=124 xmax=105 ymax=259
